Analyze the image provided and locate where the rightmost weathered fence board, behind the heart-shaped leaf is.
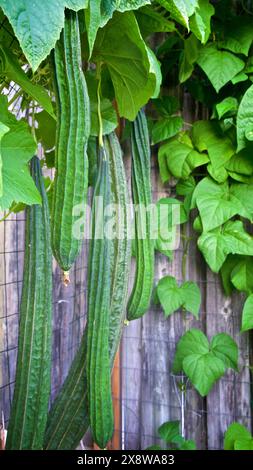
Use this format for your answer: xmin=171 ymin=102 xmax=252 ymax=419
xmin=206 ymin=270 xmax=251 ymax=449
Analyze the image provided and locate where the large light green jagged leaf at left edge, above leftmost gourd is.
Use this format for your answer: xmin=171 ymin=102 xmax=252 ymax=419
xmin=0 ymin=96 xmax=41 ymax=210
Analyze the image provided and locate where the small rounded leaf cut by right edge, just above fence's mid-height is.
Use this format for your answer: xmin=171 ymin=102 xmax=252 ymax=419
xmin=231 ymin=256 xmax=253 ymax=294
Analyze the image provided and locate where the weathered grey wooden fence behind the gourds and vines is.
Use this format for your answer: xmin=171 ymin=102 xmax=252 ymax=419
xmin=0 ymin=95 xmax=252 ymax=449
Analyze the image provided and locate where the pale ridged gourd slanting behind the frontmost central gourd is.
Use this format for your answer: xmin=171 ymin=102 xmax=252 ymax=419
xmin=44 ymin=133 xmax=131 ymax=450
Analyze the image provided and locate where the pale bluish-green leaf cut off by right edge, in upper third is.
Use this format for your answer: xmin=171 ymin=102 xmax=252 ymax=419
xmin=236 ymin=85 xmax=253 ymax=152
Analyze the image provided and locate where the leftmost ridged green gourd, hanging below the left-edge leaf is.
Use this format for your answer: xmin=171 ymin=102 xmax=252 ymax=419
xmin=6 ymin=157 xmax=52 ymax=450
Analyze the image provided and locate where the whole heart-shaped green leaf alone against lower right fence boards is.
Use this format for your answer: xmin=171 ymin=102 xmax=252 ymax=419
xmin=173 ymin=328 xmax=238 ymax=396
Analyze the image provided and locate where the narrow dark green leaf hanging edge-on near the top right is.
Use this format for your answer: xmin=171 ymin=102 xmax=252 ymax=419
xmin=179 ymin=34 xmax=200 ymax=83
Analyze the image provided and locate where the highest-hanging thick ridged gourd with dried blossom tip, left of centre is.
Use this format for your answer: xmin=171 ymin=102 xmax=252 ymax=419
xmin=52 ymin=10 xmax=90 ymax=283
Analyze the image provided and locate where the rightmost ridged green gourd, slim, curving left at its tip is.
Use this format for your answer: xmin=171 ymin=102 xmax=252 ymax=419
xmin=127 ymin=110 xmax=154 ymax=320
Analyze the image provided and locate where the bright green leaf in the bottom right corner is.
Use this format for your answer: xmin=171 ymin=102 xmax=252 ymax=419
xmin=224 ymin=423 xmax=253 ymax=450
